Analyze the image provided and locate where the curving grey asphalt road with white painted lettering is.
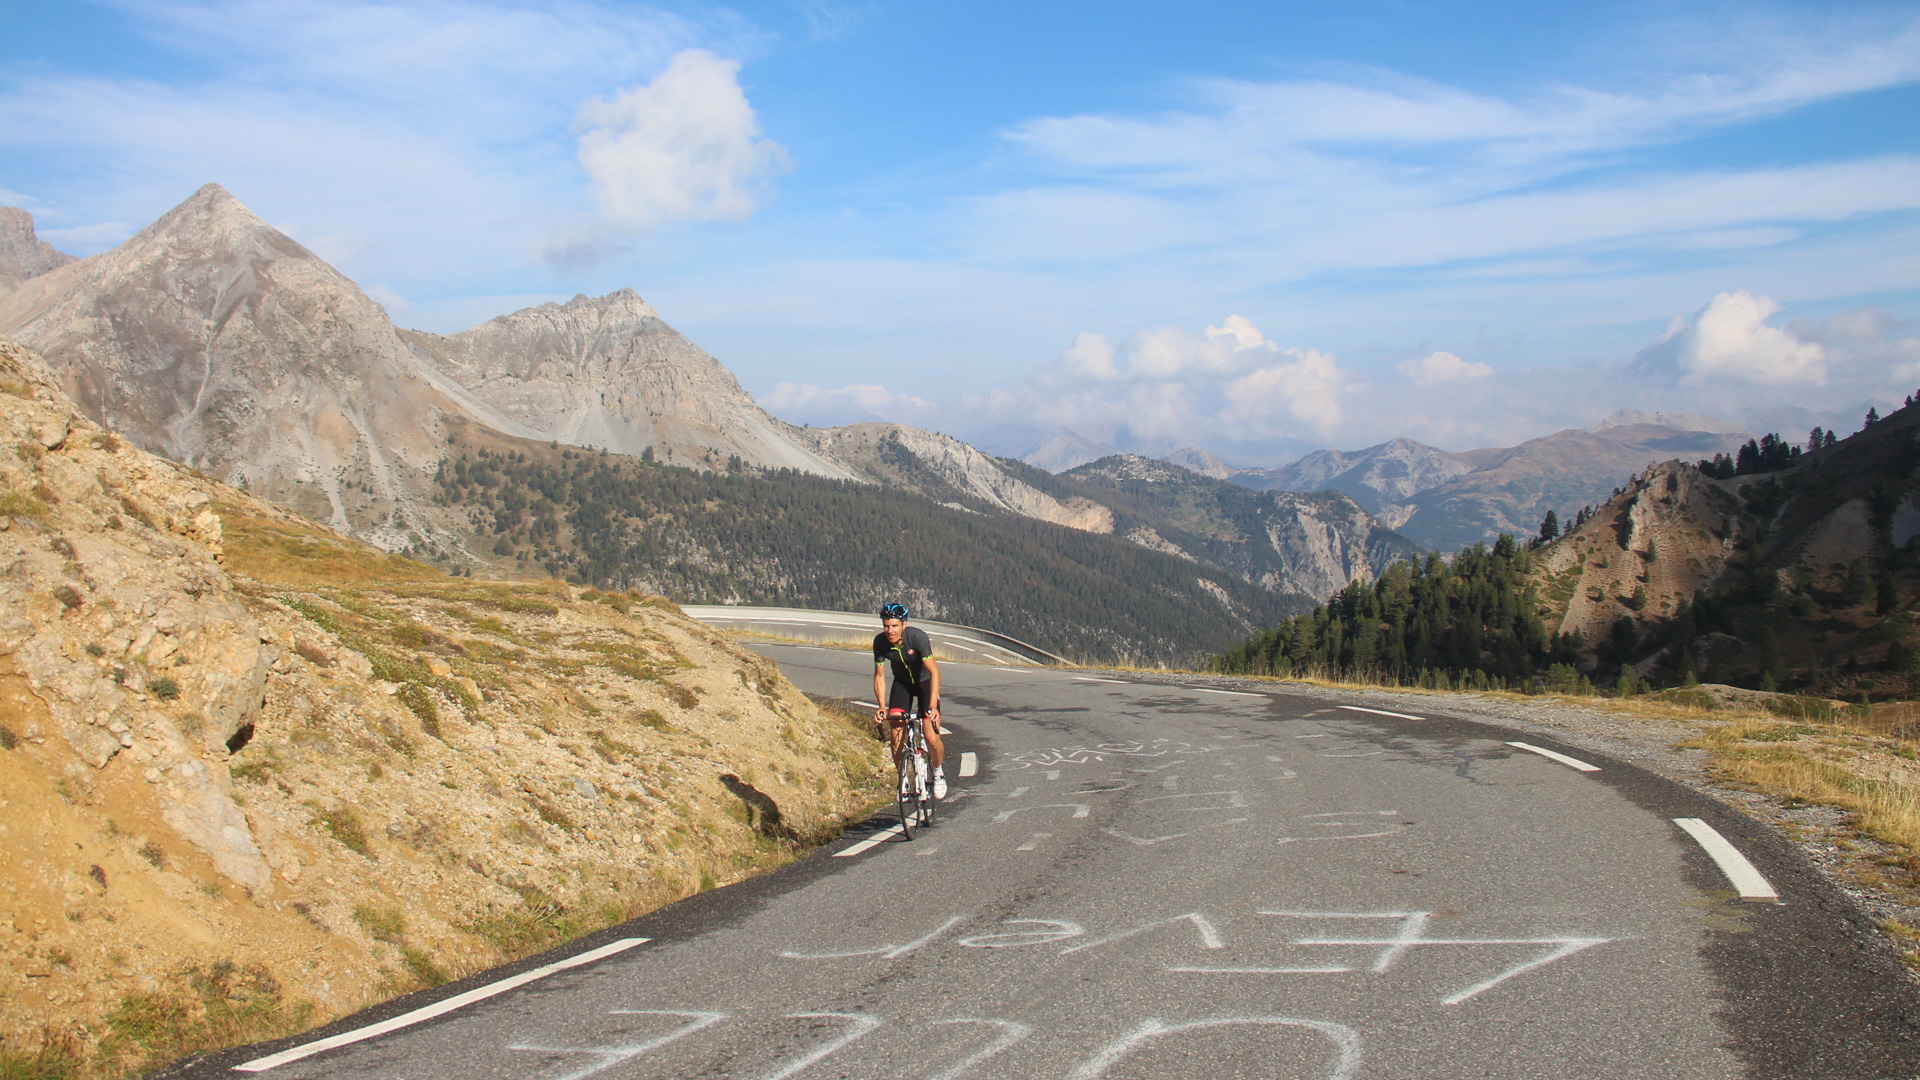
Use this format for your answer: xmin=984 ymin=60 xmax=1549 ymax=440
xmin=186 ymin=646 xmax=1920 ymax=1080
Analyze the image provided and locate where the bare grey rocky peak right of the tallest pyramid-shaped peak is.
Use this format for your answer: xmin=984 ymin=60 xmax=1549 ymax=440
xmin=403 ymin=288 xmax=851 ymax=479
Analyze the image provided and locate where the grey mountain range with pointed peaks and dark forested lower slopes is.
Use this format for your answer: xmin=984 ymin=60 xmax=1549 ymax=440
xmin=0 ymin=184 xmax=1409 ymax=659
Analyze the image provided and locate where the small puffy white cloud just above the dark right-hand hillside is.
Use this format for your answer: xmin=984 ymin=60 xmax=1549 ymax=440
xmin=1659 ymin=288 xmax=1828 ymax=386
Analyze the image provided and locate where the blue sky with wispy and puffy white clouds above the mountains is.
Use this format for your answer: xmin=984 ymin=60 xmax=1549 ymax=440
xmin=0 ymin=0 xmax=1920 ymax=463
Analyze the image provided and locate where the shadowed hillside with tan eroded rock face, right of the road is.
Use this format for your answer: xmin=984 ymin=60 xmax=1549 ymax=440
xmin=1540 ymin=405 xmax=1920 ymax=700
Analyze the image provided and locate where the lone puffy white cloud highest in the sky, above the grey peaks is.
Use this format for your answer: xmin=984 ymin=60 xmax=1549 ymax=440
xmin=578 ymin=48 xmax=787 ymax=229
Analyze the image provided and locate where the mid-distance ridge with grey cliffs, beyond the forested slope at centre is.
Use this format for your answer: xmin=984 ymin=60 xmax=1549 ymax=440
xmin=1004 ymin=454 xmax=1417 ymax=600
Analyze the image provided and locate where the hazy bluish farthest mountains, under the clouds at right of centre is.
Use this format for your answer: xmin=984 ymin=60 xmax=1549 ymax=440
xmin=1233 ymin=413 xmax=1749 ymax=552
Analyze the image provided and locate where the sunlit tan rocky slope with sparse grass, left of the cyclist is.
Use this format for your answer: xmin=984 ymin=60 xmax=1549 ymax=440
xmin=0 ymin=340 xmax=883 ymax=1074
